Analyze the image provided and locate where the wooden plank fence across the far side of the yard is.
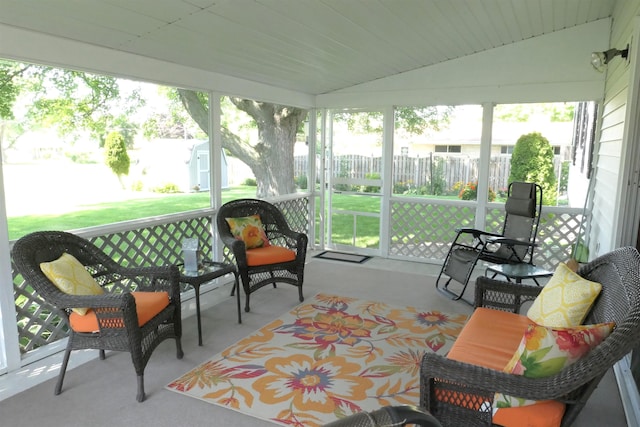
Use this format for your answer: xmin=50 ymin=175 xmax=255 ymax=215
xmin=294 ymin=153 xmax=548 ymax=192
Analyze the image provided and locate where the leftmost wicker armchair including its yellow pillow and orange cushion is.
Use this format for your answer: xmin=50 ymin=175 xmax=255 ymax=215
xmin=12 ymin=231 xmax=183 ymax=402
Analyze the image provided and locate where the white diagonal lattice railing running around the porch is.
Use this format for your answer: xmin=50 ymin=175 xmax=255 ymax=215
xmin=13 ymin=196 xmax=581 ymax=364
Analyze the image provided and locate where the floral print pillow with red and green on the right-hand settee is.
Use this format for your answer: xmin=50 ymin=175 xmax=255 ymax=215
xmin=494 ymin=322 xmax=615 ymax=408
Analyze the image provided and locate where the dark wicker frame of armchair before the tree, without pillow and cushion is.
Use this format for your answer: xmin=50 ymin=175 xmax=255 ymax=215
xmin=216 ymin=199 xmax=308 ymax=311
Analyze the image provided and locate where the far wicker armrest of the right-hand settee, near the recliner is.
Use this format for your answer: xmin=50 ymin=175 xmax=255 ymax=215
xmin=474 ymin=276 xmax=542 ymax=313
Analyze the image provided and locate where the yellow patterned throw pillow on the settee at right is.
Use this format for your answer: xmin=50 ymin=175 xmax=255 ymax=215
xmin=527 ymin=263 xmax=602 ymax=328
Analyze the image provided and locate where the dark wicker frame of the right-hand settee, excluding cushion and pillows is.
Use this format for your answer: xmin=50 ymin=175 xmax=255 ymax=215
xmin=420 ymin=247 xmax=640 ymax=427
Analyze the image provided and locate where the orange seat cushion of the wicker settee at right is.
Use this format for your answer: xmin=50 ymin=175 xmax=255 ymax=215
xmin=447 ymin=307 xmax=565 ymax=427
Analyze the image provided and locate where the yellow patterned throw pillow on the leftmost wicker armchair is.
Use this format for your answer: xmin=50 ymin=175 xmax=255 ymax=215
xmin=40 ymin=253 xmax=104 ymax=316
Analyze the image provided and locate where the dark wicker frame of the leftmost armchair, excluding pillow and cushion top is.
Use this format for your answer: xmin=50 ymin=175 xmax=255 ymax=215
xmin=12 ymin=231 xmax=183 ymax=402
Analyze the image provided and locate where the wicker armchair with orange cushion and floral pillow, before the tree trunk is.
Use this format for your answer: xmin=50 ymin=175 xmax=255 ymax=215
xmin=216 ymin=199 xmax=308 ymax=312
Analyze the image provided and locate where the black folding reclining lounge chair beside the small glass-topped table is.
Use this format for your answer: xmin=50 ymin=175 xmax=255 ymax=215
xmin=436 ymin=182 xmax=542 ymax=300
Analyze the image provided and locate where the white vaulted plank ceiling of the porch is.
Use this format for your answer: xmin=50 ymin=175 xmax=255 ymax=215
xmin=0 ymin=0 xmax=615 ymax=95
